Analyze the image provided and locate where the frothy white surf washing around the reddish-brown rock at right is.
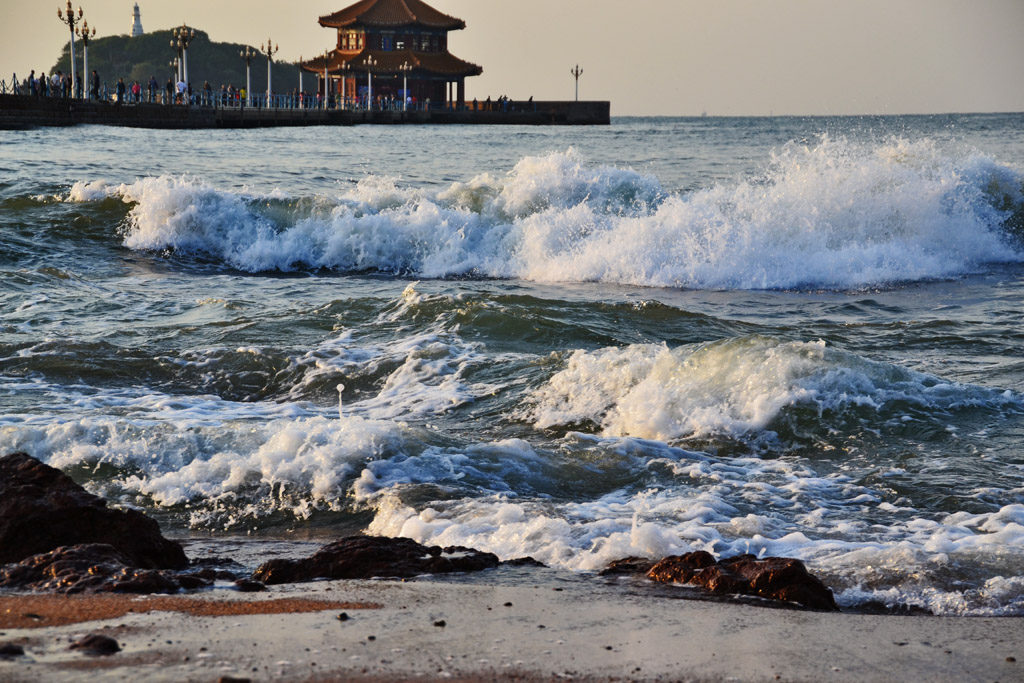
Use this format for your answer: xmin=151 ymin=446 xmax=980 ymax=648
xmin=355 ymin=434 xmax=1024 ymax=614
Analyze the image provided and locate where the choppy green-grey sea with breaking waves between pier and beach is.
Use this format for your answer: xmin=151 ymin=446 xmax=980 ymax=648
xmin=0 ymin=115 xmax=1024 ymax=615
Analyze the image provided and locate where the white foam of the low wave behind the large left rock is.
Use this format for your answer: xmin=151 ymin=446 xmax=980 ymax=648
xmin=0 ymin=411 xmax=403 ymax=527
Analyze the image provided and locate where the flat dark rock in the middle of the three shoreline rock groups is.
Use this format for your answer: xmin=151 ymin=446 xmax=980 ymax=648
xmin=252 ymin=536 xmax=499 ymax=585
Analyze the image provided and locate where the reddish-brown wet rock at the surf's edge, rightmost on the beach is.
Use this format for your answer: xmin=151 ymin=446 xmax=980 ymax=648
xmin=647 ymin=551 xmax=839 ymax=611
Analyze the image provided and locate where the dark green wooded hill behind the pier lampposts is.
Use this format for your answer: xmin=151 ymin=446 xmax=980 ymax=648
xmin=47 ymin=29 xmax=305 ymax=93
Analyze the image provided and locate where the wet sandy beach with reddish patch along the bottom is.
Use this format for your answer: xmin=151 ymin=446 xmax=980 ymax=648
xmin=0 ymin=567 xmax=1024 ymax=682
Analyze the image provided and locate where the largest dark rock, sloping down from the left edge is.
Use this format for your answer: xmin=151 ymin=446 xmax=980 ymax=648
xmin=0 ymin=453 xmax=188 ymax=569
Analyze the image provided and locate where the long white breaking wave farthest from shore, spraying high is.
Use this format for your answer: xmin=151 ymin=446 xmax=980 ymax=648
xmin=105 ymin=143 xmax=1024 ymax=289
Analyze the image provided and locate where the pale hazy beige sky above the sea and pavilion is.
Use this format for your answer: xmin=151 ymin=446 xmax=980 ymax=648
xmin=0 ymin=0 xmax=1024 ymax=115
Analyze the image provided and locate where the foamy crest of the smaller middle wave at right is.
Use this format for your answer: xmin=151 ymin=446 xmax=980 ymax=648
xmin=530 ymin=335 xmax=1024 ymax=440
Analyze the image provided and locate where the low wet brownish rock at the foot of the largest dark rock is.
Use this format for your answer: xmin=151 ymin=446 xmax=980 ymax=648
xmin=0 ymin=544 xmax=211 ymax=594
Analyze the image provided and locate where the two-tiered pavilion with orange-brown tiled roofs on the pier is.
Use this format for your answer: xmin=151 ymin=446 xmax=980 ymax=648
xmin=301 ymin=0 xmax=483 ymax=105
